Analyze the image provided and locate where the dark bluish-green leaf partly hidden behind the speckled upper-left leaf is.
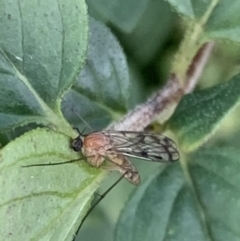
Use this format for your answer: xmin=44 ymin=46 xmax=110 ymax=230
xmin=63 ymin=19 xmax=130 ymax=131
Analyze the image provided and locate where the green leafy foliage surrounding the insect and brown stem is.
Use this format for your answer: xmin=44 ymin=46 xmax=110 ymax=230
xmin=0 ymin=0 xmax=240 ymax=241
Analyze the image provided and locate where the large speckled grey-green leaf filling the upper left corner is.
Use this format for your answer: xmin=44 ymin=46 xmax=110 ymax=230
xmin=0 ymin=0 xmax=88 ymax=130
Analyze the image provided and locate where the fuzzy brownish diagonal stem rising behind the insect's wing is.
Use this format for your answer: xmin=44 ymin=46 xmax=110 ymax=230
xmin=108 ymin=42 xmax=214 ymax=131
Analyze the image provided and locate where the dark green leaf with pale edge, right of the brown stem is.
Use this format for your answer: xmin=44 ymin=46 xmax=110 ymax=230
xmin=169 ymin=75 xmax=240 ymax=151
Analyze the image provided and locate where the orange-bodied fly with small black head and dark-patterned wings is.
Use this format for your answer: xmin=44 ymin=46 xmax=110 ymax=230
xmin=71 ymin=130 xmax=179 ymax=185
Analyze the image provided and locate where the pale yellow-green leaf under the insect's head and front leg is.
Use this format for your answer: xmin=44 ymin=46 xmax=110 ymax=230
xmin=0 ymin=129 xmax=103 ymax=241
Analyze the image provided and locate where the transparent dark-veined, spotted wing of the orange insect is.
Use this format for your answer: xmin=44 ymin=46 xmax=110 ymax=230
xmin=102 ymin=131 xmax=180 ymax=162
